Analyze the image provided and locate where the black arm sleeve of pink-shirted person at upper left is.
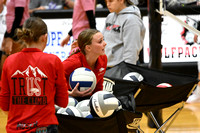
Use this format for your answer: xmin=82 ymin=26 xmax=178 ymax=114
xmin=5 ymin=7 xmax=24 ymax=38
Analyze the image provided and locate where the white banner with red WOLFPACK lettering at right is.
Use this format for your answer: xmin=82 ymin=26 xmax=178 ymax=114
xmin=143 ymin=15 xmax=200 ymax=63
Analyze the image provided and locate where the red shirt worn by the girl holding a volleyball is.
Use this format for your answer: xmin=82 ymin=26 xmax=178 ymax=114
xmin=63 ymin=52 xmax=107 ymax=94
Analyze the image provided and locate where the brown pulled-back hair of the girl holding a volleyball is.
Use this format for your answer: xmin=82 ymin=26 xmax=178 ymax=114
xmin=70 ymin=29 xmax=100 ymax=56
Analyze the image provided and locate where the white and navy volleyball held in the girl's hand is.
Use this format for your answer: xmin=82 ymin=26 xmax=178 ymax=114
xmin=69 ymin=67 xmax=96 ymax=91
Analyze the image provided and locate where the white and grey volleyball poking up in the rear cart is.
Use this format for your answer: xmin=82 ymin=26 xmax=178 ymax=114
xmin=123 ymin=72 xmax=144 ymax=82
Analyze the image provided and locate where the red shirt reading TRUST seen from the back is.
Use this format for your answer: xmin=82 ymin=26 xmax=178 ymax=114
xmin=0 ymin=48 xmax=68 ymax=133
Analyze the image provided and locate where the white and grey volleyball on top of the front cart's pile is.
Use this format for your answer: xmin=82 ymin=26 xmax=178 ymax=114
xmin=89 ymin=91 xmax=119 ymax=118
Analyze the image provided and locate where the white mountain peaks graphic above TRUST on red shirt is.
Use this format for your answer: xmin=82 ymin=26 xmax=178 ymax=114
xmin=11 ymin=65 xmax=47 ymax=78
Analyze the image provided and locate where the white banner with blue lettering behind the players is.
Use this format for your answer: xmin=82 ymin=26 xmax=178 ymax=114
xmin=43 ymin=18 xmax=105 ymax=61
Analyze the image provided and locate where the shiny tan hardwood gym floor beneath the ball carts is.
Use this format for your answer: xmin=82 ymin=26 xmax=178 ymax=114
xmin=0 ymin=102 xmax=200 ymax=133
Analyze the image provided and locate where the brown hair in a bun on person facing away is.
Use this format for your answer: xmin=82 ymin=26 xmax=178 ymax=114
xmin=17 ymin=17 xmax=47 ymax=45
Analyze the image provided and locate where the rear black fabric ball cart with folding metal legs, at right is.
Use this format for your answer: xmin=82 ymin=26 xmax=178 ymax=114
xmin=105 ymin=62 xmax=198 ymax=133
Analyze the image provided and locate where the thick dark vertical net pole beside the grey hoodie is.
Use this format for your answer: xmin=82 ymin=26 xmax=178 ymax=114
xmin=148 ymin=0 xmax=162 ymax=69
